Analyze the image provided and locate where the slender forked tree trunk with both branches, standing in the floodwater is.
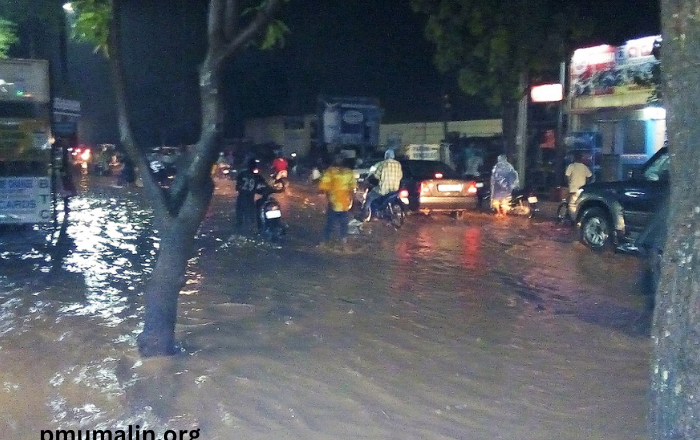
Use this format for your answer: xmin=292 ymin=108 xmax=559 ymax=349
xmin=108 ymin=0 xmax=282 ymax=356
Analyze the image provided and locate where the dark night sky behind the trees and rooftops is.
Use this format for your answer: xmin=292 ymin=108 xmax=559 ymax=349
xmin=63 ymin=0 xmax=659 ymax=145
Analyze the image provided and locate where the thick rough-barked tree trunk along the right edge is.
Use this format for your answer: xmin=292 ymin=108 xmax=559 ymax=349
xmin=650 ymin=0 xmax=700 ymax=440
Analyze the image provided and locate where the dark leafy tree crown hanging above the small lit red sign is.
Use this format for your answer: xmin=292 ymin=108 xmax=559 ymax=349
xmin=411 ymin=0 xmax=592 ymax=151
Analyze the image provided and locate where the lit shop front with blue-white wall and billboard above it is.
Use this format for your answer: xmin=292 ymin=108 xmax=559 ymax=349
xmin=565 ymin=36 xmax=666 ymax=180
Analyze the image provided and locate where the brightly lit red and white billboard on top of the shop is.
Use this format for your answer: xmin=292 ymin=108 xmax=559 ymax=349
xmin=569 ymin=35 xmax=661 ymax=97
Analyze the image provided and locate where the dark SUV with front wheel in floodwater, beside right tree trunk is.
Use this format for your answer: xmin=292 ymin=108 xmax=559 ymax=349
xmin=569 ymin=147 xmax=669 ymax=250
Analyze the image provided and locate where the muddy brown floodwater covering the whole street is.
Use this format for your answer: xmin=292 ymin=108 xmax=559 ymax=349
xmin=0 ymin=176 xmax=650 ymax=440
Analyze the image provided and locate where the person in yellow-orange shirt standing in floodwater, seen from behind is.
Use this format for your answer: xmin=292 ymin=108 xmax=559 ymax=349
xmin=318 ymin=155 xmax=355 ymax=250
